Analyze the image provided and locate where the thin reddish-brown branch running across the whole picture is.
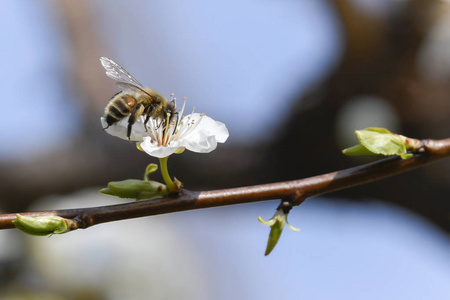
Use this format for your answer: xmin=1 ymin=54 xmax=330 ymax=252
xmin=0 ymin=139 xmax=450 ymax=229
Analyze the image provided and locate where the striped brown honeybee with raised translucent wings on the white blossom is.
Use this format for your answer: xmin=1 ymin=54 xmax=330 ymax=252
xmin=100 ymin=57 xmax=178 ymax=141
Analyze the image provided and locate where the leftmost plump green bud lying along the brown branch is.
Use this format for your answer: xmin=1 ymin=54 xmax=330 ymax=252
xmin=13 ymin=214 xmax=71 ymax=236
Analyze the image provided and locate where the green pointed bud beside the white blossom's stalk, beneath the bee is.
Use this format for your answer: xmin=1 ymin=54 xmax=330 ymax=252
xmin=100 ymin=179 xmax=167 ymax=200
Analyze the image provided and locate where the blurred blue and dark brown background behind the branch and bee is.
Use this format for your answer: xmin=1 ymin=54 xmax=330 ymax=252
xmin=0 ymin=0 xmax=450 ymax=299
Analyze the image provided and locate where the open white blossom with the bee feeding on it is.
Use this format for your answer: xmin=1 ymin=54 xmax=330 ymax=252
xmin=101 ymin=101 xmax=229 ymax=158
